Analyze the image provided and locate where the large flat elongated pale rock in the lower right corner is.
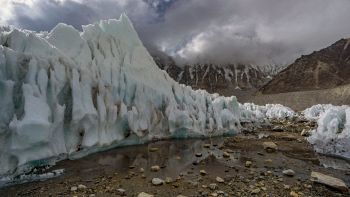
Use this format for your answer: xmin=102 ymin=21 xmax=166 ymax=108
xmin=311 ymin=171 xmax=348 ymax=192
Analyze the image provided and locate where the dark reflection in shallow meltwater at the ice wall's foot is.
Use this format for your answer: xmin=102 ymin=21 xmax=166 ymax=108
xmin=82 ymin=138 xmax=240 ymax=177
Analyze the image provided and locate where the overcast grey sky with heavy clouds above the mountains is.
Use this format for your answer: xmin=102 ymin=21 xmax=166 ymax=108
xmin=0 ymin=0 xmax=350 ymax=64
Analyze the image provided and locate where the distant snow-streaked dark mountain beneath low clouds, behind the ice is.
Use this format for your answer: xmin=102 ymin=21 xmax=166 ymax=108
xmin=150 ymin=48 xmax=284 ymax=100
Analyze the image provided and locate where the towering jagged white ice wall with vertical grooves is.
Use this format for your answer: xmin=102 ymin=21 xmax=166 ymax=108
xmin=0 ymin=15 xmax=240 ymax=177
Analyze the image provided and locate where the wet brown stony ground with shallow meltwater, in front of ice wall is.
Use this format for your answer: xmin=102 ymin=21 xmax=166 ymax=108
xmin=0 ymin=119 xmax=350 ymax=197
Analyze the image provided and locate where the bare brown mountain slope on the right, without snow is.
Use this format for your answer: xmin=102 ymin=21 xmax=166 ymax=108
xmin=260 ymin=39 xmax=350 ymax=94
